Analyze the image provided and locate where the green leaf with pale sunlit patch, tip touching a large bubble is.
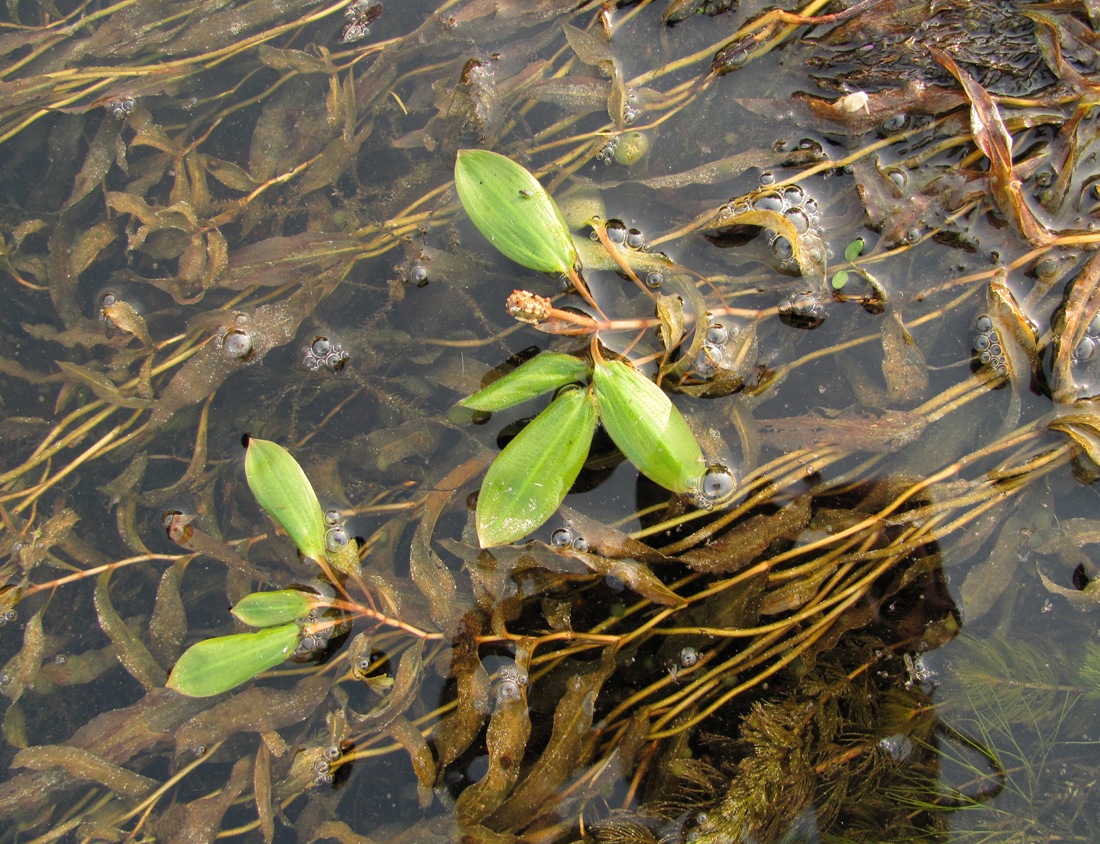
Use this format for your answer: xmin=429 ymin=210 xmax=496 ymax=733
xmin=592 ymin=361 xmax=704 ymax=492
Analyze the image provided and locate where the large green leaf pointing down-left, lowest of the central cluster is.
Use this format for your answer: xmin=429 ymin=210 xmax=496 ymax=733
xmin=476 ymin=390 xmax=596 ymax=548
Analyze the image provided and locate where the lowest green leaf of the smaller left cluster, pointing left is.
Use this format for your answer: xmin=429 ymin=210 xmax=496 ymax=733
xmin=167 ymin=622 xmax=298 ymax=698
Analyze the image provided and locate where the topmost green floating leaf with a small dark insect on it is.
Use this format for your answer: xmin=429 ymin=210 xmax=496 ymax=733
xmin=454 ymin=150 xmax=578 ymax=273
